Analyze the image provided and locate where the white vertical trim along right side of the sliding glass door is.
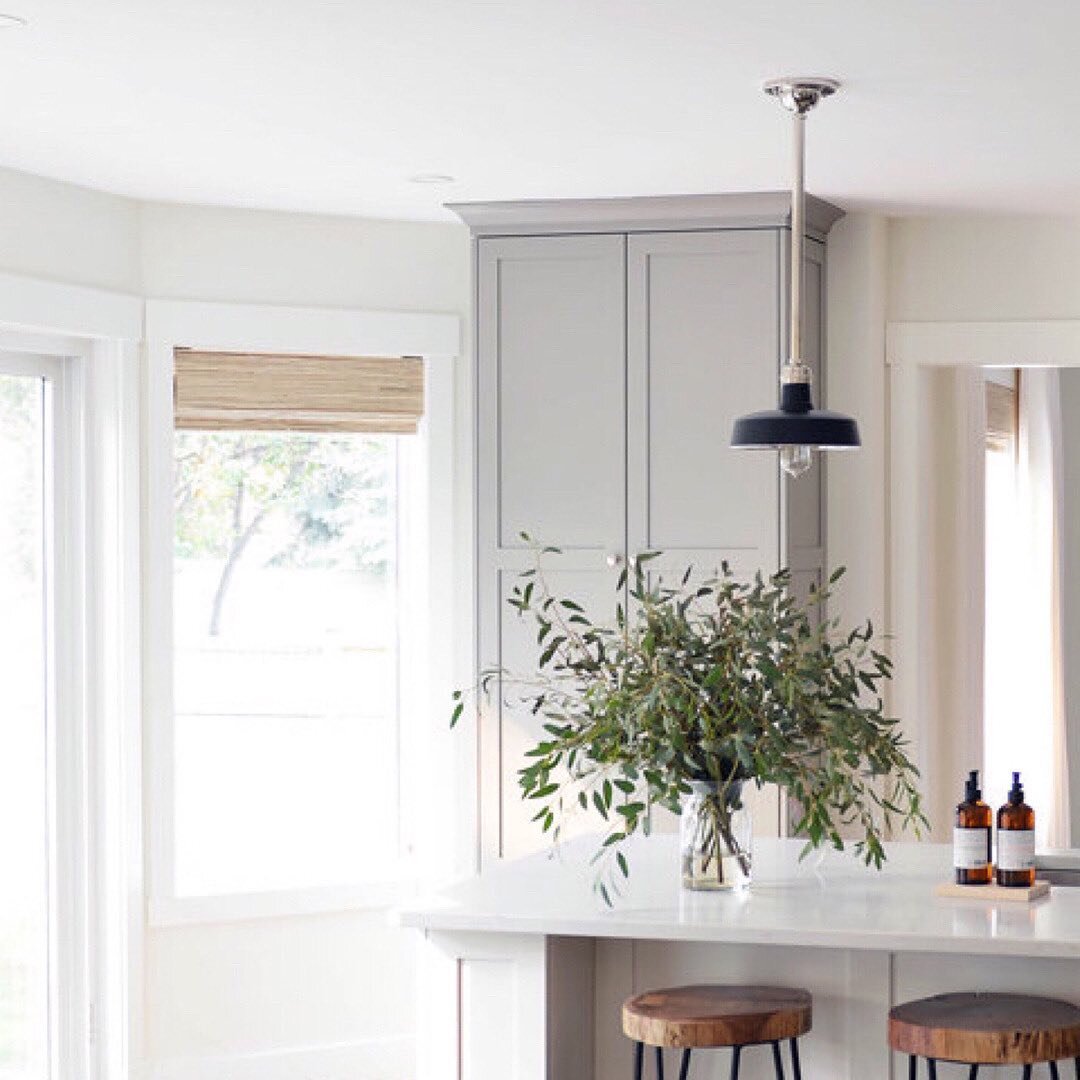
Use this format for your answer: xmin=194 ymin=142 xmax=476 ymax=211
xmin=80 ymin=340 xmax=144 ymax=1077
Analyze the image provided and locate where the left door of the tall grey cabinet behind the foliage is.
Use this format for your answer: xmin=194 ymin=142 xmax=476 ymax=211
xmin=477 ymin=235 xmax=626 ymax=859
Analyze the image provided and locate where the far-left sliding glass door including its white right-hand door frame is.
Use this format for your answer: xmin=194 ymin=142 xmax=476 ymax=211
xmin=0 ymin=351 xmax=91 ymax=1080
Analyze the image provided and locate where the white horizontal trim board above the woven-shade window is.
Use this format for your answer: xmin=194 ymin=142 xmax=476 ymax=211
xmin=146 ymin=299 xmax=461 ymax=357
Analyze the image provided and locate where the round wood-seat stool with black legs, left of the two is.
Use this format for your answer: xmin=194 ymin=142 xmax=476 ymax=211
xmin=622 ymin=986 xmax=812 ymax=1080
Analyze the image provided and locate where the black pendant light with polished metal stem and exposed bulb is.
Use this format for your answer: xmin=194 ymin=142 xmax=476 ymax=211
xmin=731 ymin=79 xmax=860 ymax=476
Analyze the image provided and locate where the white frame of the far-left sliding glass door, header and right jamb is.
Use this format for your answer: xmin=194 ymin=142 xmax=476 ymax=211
xmin=0 ymin=274 xmax=143 ymax=1080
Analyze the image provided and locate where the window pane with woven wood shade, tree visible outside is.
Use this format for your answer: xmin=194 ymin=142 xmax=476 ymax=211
xmin=172 ymin=351 xmax=422 ymax=899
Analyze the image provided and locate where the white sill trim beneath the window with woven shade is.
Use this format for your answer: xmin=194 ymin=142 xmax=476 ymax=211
xmin=147 ymin=881 xmax=409 ymax=927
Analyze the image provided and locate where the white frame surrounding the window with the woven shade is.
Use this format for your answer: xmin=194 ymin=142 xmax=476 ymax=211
xmin=143 ymin=300 xmax=461 ymax=926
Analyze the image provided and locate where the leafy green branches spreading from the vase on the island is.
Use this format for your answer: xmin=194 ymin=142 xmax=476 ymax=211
xmin=451 ymin=538 xmax=926 ymax=904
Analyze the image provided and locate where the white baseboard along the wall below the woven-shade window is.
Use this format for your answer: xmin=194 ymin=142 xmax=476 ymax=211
xmin=141 ymin=1036 xmax=416 ymax=1080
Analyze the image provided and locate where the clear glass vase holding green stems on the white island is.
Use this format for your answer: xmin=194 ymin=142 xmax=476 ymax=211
xmin=679 ymin=780 xmax=753 ymax=890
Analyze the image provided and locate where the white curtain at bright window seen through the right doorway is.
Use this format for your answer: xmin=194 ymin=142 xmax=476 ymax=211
xmin=985 ymin=368 xmax=1070 ymax=848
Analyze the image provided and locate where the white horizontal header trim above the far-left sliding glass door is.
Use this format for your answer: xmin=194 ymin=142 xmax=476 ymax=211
xmin=0 ymin=273 xmax=143 ymax=341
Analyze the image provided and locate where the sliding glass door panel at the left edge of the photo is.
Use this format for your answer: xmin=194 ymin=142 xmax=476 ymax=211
xmin=0 ymin=352 xmax=68 ymax=1080
